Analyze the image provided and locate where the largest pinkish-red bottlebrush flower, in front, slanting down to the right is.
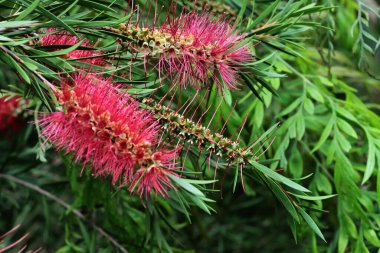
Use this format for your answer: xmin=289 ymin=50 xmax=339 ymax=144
xmin=39 ymin=74 xmax=178 ymax=196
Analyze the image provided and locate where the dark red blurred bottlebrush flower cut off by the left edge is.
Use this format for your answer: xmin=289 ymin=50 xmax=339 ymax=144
xmin=0 ymin=96 xmax=22 ymax=134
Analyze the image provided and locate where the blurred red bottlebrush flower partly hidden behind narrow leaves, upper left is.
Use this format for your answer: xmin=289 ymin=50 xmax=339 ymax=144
xmin=38 ymin=28 xmax=105 ymax=66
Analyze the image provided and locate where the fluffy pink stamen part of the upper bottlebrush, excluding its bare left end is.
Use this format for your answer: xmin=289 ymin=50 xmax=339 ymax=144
xmin=164 ymin=13 xmax=252 ymax=89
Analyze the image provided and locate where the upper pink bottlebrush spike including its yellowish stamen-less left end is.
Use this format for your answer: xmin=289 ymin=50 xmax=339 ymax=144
xmin=114 ymin=13 xmax=252 ymax=89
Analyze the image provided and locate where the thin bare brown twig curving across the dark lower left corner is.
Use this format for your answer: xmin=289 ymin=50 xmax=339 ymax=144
xmin=0 ymin=174 xmax=128 ymax=253
